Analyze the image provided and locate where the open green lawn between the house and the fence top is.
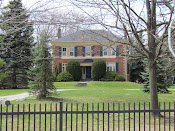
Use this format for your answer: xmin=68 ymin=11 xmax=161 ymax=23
xmin=0 ymin=81 xmax=175 ymax=103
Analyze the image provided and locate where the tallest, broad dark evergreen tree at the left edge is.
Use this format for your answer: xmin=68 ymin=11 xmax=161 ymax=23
xmin=0 ymin=0 xmax=34 ymax=88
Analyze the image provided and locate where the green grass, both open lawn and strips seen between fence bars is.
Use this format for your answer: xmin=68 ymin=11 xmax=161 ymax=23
xmin=0 ymin=81 xmax=175 ymax=130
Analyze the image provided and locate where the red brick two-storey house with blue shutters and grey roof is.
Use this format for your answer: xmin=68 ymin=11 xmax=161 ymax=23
xmin=51 ymin=29 xmax=129 ymax=80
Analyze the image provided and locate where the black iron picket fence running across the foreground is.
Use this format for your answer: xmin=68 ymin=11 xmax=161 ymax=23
xmin=0 ymin=102 xmax=175 ymax=131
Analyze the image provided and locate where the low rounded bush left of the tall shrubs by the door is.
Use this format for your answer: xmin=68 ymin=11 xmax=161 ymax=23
xmin=57 ymin=72 xmax=73 ymax=81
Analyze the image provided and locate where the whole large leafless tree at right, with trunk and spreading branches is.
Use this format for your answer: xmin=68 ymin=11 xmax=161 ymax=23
xmin=66 ymin=0 xmax=174 ymax=109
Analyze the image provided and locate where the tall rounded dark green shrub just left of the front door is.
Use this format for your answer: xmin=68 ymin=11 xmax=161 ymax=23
xmin=66 ymin=60 xmax=81 ymax=81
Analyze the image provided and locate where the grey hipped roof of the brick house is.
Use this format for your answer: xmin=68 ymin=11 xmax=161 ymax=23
xmin=52 ymin=30 xmax=119 ymax=42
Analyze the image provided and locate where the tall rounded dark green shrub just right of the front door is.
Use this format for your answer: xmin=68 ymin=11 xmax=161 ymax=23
xmin=92 ymin=60 xmax=106 ymax=80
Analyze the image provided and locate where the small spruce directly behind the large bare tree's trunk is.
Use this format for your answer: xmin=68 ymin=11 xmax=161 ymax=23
xmin=142 ymin=58 xmax=170 ymax=93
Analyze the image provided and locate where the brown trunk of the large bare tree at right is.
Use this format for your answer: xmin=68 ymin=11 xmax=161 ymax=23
xmin=146 ymin=0 xmax=159 ymax=114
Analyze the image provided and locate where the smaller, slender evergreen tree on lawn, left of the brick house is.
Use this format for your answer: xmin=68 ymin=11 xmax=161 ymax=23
xmin=29 ymin=33 xmax=55 ymax=99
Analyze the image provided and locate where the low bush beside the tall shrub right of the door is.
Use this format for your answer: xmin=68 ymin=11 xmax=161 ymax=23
xmin=100 ymin=71 xmax=118 ymax=81
